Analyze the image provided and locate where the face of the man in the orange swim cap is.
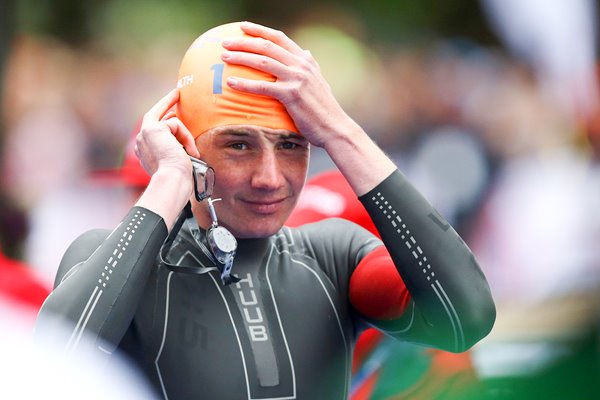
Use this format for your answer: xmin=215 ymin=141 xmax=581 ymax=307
xmin=195 ymin=125 xmax=309 ymax=238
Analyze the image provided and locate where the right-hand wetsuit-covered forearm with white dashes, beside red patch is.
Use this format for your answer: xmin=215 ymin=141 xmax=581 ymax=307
xmin=360 ymin=171 xmax=495 ymax=351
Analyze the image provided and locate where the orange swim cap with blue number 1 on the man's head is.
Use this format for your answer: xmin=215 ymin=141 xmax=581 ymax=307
xmin=176 ymin=22 xmax=299 ymax=138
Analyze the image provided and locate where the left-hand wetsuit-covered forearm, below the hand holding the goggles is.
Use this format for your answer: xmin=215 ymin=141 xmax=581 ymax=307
xmin=36 ymin=207 xmax=167 ymax=352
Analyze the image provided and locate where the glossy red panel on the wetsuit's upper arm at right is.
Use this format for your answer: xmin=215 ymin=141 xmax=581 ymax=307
xmin=350 ymin=246 xmax=410 ymax=319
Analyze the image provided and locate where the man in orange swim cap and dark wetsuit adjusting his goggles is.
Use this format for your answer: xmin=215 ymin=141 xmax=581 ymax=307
xmin=37 ymin=22 xmax=495 ymax=399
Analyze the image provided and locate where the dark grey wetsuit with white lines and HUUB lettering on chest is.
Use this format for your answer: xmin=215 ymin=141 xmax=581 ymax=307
xmin=37 ymin=172 xmax=494 ymax=400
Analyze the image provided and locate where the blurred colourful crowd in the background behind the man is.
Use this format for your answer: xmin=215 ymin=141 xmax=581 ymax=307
xmin=0 ymin=0 xmax=600 ymax=399
